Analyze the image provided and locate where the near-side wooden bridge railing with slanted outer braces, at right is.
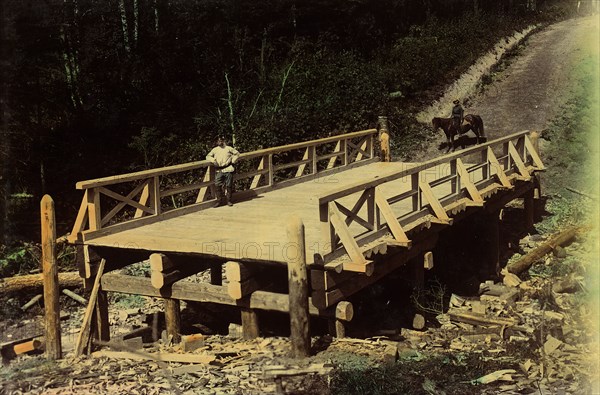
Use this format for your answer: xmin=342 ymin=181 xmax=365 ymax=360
xmin=319 ymin=131 xmax=544 ymax=273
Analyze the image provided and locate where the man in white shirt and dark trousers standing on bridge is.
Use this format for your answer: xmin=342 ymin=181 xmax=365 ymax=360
xmin=206 ymin=136 xmax=240 ymax=207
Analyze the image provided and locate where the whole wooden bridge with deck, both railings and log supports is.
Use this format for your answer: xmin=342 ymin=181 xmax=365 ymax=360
xmin=69 ymin=123 xmax=544 ymax=352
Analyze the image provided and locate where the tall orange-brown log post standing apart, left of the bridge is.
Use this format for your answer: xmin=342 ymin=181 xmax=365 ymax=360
xmin=40 ymin=195 xmax=62 ymax=359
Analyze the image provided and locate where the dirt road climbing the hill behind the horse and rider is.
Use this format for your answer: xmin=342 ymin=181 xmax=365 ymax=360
xmin=427 ymin=15 xmax=599 ymax=157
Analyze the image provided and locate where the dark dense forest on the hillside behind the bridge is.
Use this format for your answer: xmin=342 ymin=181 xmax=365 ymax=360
xmin=0 ymin=0 xmax=577 ymax=277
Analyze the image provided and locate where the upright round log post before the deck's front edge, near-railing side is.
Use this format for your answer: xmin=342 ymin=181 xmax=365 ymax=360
xmin=285 ymin=216 xmax=310 ymax=358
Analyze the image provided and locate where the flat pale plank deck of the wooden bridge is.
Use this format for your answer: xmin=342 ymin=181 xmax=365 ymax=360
xmin=86 ymin=162 xmax=488 ymax=264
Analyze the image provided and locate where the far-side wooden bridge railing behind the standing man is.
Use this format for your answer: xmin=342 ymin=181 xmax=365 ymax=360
xmin=69 ymin=129 xmax=378 ymax=242
